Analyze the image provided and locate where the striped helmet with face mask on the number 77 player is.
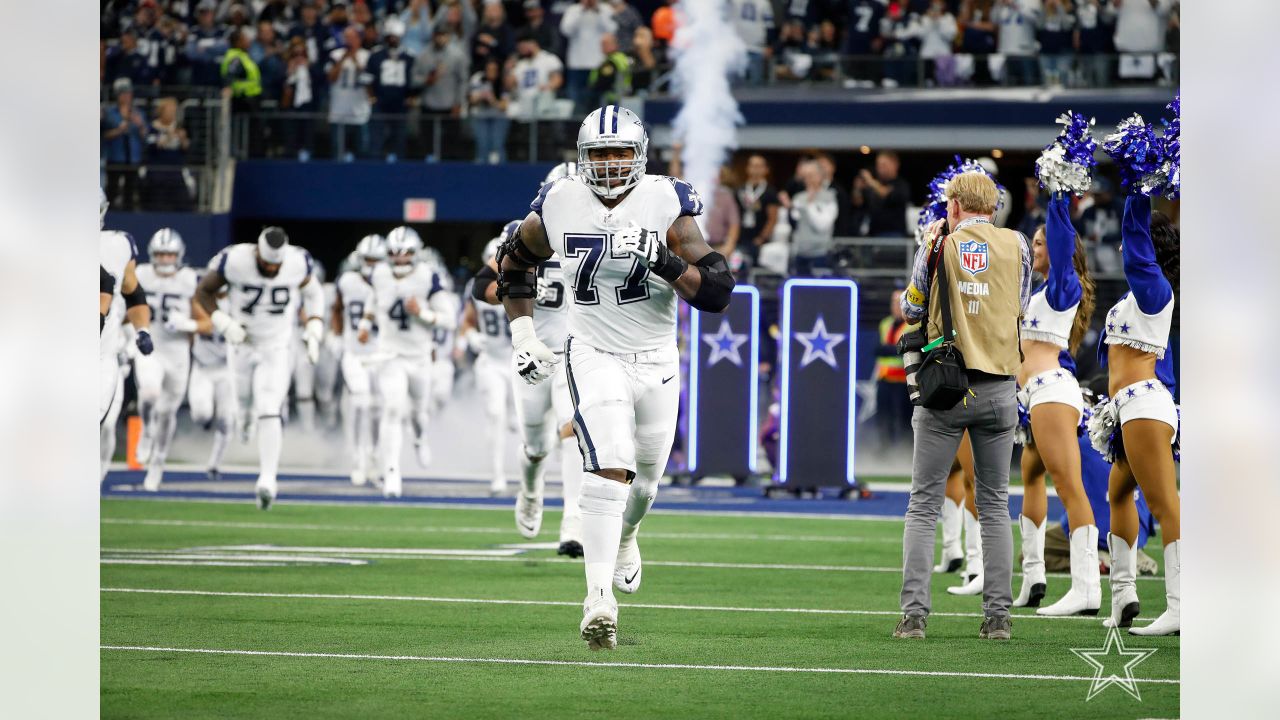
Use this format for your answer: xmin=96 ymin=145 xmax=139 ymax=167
xmin=577 ymin=105 xmax=649 ymax=197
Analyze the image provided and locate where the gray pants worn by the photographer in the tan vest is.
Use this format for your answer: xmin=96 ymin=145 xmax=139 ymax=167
xmin=901 ymin=375 xmax=1018 ymax=615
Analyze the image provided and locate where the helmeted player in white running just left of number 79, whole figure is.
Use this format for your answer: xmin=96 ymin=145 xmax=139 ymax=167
xmin=136 ymin=228 xmax=196 ymax=492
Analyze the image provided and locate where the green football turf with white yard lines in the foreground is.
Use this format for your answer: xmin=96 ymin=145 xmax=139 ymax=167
xmin=101 ymin=498 xmax=1180 ymax=720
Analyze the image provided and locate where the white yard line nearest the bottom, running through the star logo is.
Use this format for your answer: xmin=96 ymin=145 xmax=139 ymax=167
xmin=99 ymin=644 xmax=1181 ymax=685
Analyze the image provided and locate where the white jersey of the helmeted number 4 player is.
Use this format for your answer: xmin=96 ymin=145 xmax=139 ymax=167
xmin=370 ymin=263 xmax=457 ymax=356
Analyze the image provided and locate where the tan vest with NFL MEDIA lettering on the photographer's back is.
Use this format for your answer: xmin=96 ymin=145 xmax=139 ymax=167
xmin=929 ymin=223 xmax=1023 ymax=375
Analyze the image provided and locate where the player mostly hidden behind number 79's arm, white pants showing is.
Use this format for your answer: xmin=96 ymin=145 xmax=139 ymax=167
xmin=187 ymin=254 xmax=236 ymax=480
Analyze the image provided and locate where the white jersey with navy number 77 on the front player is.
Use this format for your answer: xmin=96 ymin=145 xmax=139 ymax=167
xmin=530 ymin=176 xmax=703 ymax=352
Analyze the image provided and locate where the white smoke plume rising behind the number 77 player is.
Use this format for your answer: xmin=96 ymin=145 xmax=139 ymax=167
xmin=672 ymin=0 xmax=746 ymax=205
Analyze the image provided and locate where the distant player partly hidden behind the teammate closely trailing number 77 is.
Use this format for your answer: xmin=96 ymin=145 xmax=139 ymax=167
xmin=458 ymin=236 xmax=517 ymax=497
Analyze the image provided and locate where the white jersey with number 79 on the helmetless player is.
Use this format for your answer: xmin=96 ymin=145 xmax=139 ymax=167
xmin=218 ymin=242 xmax=314 ymax=347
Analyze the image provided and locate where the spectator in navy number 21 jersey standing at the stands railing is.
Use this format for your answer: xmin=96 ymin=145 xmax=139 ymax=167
xmin=367 ymin=15 xmax=413 ymax=163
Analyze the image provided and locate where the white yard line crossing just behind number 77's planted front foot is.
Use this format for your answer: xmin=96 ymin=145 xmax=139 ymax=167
xmin=101 ymin=588 xmax=1101 ymax=623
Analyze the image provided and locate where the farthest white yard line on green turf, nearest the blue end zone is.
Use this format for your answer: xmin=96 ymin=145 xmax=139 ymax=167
xmin=101 ymin=518 xmax=902 ymax=544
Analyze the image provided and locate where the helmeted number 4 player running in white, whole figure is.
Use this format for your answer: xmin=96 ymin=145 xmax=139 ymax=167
xmin=358 ymin=225 xmax=458 ymax=497
